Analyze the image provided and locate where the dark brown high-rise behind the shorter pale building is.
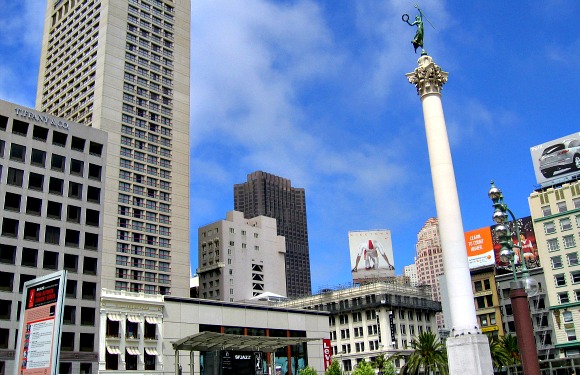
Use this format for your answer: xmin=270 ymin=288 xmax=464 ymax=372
xmin=234 ymin=171 xmax=311 ymax=297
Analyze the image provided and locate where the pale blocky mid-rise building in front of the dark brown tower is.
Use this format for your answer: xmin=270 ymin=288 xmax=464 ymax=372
xmin=197 ymin=211 xmax=286 ymax=302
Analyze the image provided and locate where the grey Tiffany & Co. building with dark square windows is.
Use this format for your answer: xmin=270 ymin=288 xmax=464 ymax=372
xmin=0 ymin=100 xmax=108 ymax=373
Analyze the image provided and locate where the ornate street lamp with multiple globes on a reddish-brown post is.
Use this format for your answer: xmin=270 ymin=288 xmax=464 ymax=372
xmin=488 ymin=181 xmax=540 ymax=375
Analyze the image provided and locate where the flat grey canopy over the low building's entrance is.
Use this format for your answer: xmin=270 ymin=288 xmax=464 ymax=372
xmin=172 ymin=332 xmax=321 ymax=352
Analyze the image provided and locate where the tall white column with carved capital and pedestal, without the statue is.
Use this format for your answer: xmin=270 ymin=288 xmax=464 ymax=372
xmin=406 ymin=55 xmax=493 ymax=375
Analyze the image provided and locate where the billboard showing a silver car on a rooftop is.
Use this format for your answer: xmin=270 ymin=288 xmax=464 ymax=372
xmin=530 ymin=133 xmax=580 ymax=186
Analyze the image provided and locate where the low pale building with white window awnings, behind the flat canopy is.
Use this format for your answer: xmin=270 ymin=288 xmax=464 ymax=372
xmin=99 ymin=290 xmax=329 ymax=374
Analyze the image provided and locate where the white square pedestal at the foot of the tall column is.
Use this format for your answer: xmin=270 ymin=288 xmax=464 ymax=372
xmin=447 ymin=333 xmax=493 ymax=375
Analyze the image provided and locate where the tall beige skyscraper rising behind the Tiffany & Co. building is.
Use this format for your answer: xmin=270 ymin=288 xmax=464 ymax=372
xmin=36 ymin=0 xmax=190 ymax=296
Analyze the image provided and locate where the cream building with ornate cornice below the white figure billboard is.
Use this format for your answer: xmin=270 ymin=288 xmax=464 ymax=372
xmin=281 ymin=280 xmax=441 ymax=372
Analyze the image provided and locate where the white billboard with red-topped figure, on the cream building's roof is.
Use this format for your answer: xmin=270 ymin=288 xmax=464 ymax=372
xmin=348 ymin=229 xmax=395 ymax=283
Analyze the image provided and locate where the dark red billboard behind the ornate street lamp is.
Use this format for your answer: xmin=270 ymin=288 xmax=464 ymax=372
xmin=491 ymin=216 xmax=540 ymax=269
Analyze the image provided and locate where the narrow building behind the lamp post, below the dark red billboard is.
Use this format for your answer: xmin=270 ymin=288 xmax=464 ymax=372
xmin=495 ymin=267 xmax=558 ymax=360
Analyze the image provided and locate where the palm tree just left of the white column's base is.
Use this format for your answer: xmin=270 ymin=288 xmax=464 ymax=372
xmin=389 ymin=332 xmax=449 ymax=375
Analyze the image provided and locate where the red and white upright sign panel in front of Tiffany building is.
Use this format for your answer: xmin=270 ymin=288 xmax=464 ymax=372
xmin=14 ymin=271 xmax=66 ymax=375
